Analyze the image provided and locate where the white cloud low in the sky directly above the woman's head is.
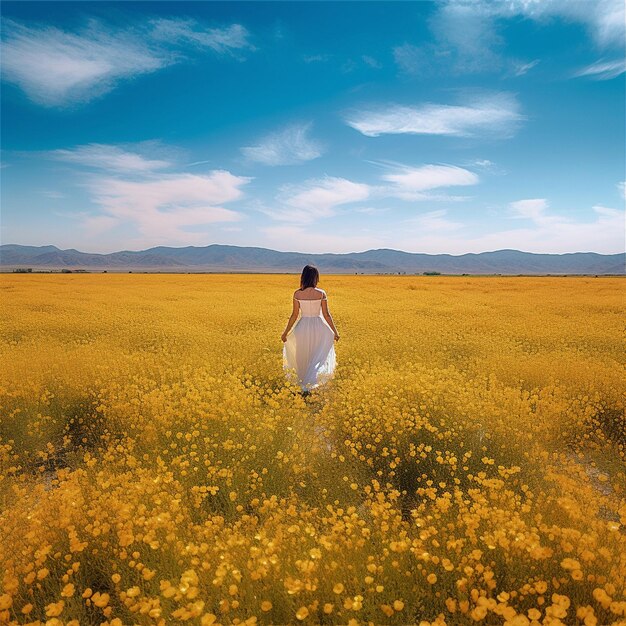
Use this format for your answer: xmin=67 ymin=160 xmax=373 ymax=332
xmin=261 ymin=176 xmax=370 ymax=224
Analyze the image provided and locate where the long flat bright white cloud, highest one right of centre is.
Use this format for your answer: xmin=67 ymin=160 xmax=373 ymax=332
xmin=346 ymin=93 xmax=526 ymax=137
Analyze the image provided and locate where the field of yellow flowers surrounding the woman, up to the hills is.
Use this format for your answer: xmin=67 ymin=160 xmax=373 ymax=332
xmin=0 ymin=274 xmax=626 ymax=626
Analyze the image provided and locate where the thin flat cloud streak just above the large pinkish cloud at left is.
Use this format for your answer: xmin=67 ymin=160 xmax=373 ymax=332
xmin=48 ymin=142 xmax=172 ymax=173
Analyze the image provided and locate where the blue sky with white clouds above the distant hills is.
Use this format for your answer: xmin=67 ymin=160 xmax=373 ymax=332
xmin=0 ymin=0 xmax=626 ymax=254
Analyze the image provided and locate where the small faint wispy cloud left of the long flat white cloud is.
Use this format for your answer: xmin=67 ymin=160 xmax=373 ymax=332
xmin=241 ymin=122 xmax=324 ymax=165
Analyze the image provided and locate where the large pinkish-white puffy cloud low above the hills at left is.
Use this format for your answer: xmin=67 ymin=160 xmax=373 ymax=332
xmin=82 ymin=170 xmax=251 ymax=245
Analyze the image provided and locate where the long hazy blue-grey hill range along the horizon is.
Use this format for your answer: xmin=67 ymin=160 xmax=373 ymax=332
xmin=0 ymin=244 xmax=626 ymax=274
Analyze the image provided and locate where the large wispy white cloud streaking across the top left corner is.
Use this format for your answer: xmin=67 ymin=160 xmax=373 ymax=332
xmin=2 ymin=19 xmax=251 ymax=107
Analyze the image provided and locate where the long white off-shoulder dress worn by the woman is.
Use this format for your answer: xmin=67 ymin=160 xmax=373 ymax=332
xmin=283 ymin=290 xmax=336 ymax=391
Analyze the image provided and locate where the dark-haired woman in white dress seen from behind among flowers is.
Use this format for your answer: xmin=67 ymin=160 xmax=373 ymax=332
xmin=281 ymin=265 xmax=339 ymax=395
